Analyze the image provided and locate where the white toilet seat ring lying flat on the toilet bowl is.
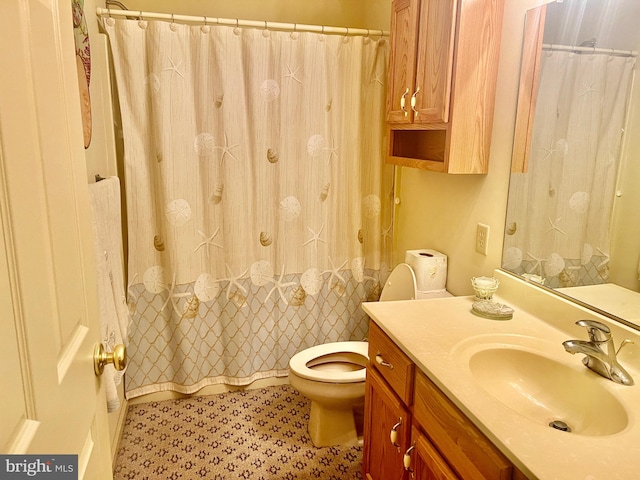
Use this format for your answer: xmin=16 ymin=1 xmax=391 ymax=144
xmin=289 ymin=342 xmax=369 ymax=383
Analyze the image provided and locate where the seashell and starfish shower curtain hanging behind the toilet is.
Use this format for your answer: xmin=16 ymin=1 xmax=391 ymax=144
xmin=104 ymin=18 xmax=393 ymax=397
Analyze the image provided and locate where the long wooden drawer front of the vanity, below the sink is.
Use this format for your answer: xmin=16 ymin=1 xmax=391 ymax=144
xmin=413 ymin=371 xmax=513 ymax=480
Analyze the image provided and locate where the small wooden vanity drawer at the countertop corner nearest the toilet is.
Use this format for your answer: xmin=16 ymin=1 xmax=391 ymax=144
xmin=369 ymin=322 xmax=414 ymax=405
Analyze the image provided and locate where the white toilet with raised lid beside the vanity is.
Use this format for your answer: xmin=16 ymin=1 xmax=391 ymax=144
xmin=289 ymin=263 xmax=451 ymax=447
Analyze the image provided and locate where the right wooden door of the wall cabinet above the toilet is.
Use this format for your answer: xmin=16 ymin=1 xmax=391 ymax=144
xmin=410 ymin=0 xmax=458 ymax=124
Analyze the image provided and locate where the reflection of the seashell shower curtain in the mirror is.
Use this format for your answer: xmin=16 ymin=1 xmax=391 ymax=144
xmin=503 ymin=51 xmax=635 ymax=287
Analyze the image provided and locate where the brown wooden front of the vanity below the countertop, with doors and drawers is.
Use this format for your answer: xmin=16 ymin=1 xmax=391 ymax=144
xmin=363 ymin=322 xmax=526 ymax=480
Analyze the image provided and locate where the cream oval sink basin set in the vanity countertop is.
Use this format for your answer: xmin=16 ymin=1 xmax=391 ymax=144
xmin=469 ymin=347 xmax=629 ymax=436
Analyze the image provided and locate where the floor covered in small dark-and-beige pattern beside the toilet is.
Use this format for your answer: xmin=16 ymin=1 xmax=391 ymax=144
xmin=114 ymin=385 xmax=362 ymax=480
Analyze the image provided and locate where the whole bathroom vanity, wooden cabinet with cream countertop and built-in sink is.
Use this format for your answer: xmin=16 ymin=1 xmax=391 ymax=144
xmin=363 ymin=271 xmax=640 ymax=480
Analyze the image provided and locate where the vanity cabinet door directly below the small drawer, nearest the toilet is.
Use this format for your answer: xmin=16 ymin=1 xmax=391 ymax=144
xmin=362 ymin=368 xmax=411 ymax=480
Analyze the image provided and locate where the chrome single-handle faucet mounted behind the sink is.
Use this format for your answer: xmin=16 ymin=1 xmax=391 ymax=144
xmin=562 ymin=320 xmax=633 ymax=385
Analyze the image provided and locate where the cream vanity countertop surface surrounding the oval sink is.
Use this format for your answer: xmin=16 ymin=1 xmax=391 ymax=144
xmin=363 ymin=272 xmax=640 ymax=480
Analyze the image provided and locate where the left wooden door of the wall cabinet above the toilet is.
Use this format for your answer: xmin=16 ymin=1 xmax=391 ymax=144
xmin=387 ymin=0 xmax=420 ymax=123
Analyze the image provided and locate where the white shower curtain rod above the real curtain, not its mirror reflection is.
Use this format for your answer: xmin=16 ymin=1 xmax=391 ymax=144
xmin=96 ymin=8 xmax=389 ymax=37
